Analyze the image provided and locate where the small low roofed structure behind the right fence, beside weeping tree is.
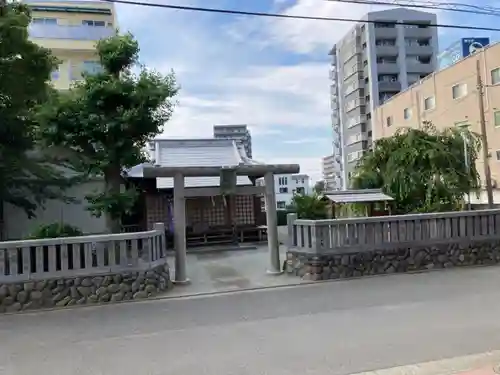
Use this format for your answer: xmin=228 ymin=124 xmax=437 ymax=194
xmin=324 ymin=189 xmax=394 ymax=217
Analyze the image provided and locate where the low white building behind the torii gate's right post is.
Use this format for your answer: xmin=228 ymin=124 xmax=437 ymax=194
xmin=257 ymin=174 xmax=312 ymax=210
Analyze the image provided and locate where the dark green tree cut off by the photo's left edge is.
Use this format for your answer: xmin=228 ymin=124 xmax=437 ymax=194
xmin=0 ymin=3 xmax=75 ymax=217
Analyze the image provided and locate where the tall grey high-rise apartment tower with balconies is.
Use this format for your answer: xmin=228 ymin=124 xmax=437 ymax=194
xmin=330 ymin=8 xmax=438 ymax=188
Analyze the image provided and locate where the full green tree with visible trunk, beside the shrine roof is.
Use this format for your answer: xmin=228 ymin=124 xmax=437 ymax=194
xmin=40 ymin=34 xmax=178 ymax=233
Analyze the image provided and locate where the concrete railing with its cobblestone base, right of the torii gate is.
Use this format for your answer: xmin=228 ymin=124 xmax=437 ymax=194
xmin=286 ymin=210 xmax=500 ymax=279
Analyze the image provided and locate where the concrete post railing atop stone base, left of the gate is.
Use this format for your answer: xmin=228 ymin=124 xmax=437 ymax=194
xmin=0 ymin=223 xmax=166 ymax=283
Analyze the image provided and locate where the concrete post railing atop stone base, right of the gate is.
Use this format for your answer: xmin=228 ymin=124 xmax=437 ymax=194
xmin=287 ymin=210 xmax=500 ymax=253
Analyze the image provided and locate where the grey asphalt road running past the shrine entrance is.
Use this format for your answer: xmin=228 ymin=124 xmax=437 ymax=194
xmin=0 ymin=267 xmax=500 ymax=375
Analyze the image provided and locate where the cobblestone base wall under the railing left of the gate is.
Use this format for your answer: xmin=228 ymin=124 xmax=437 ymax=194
xmin=0 ymin=264 xmax=172 ymax=313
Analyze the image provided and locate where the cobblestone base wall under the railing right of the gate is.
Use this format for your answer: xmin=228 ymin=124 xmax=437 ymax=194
xmin=284 ymin=240 xmax=500 ymax=280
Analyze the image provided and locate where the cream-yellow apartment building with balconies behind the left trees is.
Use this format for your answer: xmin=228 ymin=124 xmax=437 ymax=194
xmin=27 ymin=1 xmax=117 ymax=90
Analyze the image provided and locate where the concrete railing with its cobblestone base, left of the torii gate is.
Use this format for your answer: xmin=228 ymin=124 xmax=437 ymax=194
xmin=0 ymin=223 xmax=170 ymax=312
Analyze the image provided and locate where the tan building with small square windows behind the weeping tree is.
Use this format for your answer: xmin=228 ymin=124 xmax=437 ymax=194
xmin=372 ymin=44 xmax=500 ymax=203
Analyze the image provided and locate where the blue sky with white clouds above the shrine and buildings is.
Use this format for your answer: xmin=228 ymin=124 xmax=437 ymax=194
xmin=116 ymin=0 xmax=499 ymax=180
